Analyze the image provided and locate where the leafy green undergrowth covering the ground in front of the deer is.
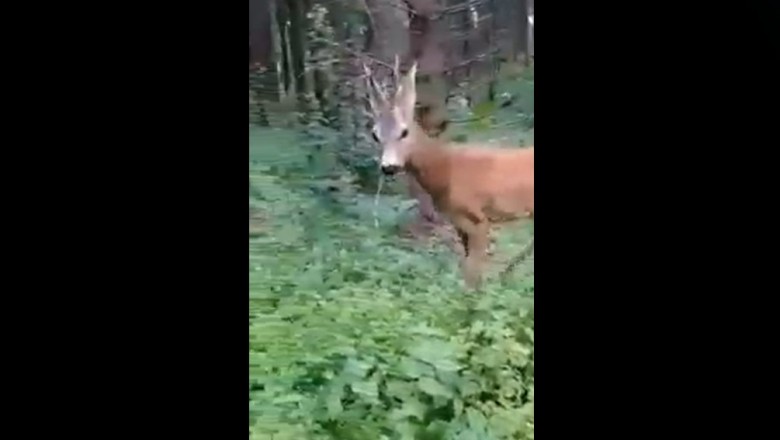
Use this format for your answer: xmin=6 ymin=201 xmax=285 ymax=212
xmin=249 ymin=71 xmax=534 ymax=440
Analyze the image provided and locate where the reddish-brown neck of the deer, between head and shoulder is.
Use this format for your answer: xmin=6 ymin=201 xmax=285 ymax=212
xmin=406 ymin=127 xmax=449 ymax=198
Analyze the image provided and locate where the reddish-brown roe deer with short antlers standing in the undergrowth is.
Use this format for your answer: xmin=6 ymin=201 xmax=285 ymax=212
xmin=363 ymin=58 xmax=534 ymax=289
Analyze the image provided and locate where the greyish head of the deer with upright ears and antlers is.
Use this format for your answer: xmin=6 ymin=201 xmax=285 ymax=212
xmin=363 ymin=56 xmax=419 ymax=175
